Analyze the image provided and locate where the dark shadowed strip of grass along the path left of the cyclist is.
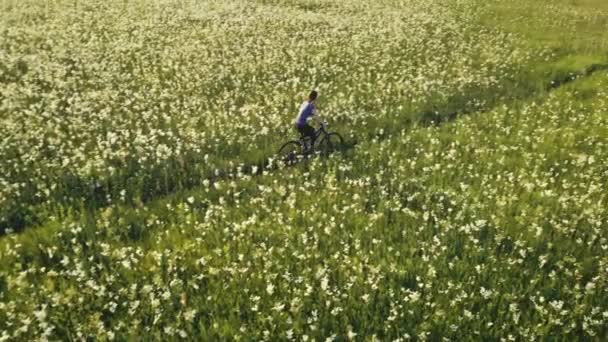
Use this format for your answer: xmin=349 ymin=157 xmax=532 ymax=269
xmin=0 ymin=136 xmax=356 ymax=236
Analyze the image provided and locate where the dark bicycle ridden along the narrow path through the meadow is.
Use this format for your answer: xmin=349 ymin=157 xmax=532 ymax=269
xmin=278 ymin=121 xmax=344 ymax=165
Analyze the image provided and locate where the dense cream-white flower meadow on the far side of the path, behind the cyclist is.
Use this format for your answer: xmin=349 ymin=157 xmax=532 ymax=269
xmin=0 ymin=1 xmax=531 ymax=228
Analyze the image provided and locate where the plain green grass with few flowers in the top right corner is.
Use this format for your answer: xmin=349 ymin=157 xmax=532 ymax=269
xmin=481 ymin=0 xmax=608 ymax=97
